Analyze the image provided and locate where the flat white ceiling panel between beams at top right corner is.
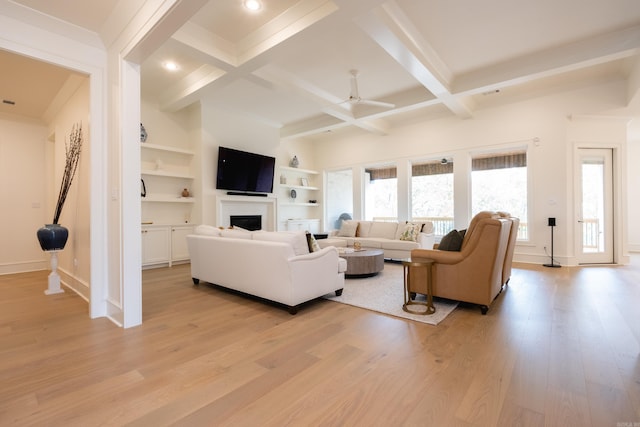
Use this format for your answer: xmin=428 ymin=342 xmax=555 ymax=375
xmin=396 ymin=0 xmax=640 ymax=74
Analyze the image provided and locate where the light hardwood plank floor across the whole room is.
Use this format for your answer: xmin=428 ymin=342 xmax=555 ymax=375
xmin=0 ymin=257 xmax=640 ymax=427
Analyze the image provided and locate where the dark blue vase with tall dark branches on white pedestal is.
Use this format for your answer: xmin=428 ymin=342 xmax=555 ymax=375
xmin=37 ymin=122 xmax=82 ymax=251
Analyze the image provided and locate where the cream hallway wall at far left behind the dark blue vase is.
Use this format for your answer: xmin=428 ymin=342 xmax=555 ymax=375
xmin=0 ymin=116 xmax=48 ymax=274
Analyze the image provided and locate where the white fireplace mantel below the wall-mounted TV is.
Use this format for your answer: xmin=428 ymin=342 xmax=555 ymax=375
xmin=216 ymin=195 xmax=276 ymax=231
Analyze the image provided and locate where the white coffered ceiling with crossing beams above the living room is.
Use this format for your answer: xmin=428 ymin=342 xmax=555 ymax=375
xmin=0 ymin=0 xmax=640 ymax=137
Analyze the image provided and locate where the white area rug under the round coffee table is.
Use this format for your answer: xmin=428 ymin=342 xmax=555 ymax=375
xmin=324 ymin=262 xmax=458 ymax=325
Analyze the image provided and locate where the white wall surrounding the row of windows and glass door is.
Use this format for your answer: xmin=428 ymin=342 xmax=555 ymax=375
xmin=308 ymin=81 xmax=637 ymax=265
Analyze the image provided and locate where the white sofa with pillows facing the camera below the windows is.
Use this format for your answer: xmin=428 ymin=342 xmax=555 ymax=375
xmin=318 ymin=220 xmax=435 ymax=259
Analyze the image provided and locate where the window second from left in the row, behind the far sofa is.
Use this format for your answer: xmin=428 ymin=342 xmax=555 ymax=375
xmin=364 ymin=166 xmax=398 ymax=221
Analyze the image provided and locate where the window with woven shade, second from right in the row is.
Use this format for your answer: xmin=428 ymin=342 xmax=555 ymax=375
xmin=411 ymin=159 xmax=454 ymax=236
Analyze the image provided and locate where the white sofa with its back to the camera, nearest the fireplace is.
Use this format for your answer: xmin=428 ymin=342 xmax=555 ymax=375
xmin=187 ymin=225 xmax=347 ymax=314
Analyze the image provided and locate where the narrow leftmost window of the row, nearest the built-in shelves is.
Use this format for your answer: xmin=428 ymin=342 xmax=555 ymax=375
xmin=325 ymin=169 xmax=353 ymax=230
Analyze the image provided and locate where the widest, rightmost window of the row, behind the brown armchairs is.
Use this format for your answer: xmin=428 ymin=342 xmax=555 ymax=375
xmin=471 ymin=150 xmax=529 ymax=240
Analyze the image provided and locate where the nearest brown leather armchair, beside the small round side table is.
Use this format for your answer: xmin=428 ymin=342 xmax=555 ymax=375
xmin=408 ymin=211 xmax=512 ymax=314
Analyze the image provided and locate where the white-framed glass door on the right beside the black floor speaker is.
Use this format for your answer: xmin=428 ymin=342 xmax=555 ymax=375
xmin=575 ymin=148 xmax=614 ymax=264
